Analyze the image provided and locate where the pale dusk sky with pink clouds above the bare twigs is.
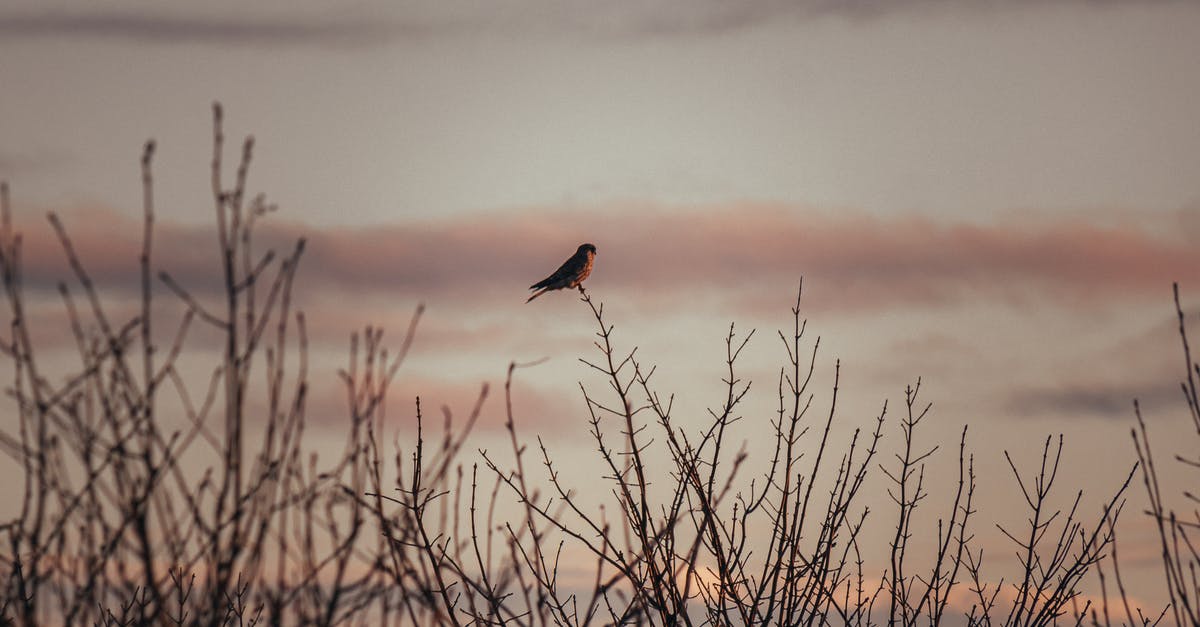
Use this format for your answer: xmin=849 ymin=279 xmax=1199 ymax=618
xmin=0 ymin=0 xmax=1200 ymax=612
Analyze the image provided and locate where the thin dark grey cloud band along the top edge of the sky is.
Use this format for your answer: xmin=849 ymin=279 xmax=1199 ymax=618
xmin=0 ymin=0 xmax=1186 ymax=48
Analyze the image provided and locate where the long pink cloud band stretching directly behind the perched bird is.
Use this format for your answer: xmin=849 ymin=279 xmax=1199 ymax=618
xmin=14 ymin=204 xmax=1200 ymax=309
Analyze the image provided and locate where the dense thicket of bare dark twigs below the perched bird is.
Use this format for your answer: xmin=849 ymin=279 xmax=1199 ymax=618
xmin=0 ymin=107 xmax=1156 ymax=626
